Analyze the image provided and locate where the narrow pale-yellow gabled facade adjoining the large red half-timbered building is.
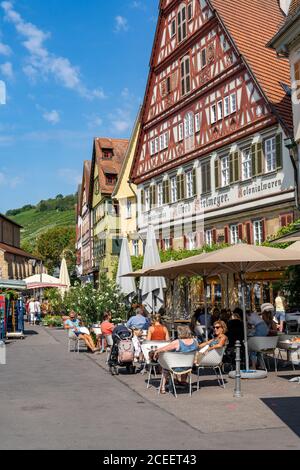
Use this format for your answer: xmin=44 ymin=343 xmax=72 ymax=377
xmin=112 ymin=117 xmax=143 ymax=256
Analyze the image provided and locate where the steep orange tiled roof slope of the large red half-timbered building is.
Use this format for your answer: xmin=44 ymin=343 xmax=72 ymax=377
xmin=209 ymin=0 xmax=293 ymax=133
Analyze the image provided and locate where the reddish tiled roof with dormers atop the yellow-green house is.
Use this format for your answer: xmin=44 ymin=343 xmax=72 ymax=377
xmin=93 ymin=137 xmax=129 ymax=195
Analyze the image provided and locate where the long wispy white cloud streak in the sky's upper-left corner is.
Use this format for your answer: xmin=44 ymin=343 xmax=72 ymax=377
xmin=1 ymin=1 xmax=105 ymax=100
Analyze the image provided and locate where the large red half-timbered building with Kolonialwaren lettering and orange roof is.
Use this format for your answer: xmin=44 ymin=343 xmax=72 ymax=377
xmin=131 ymin=0 xmax=297 ymax=253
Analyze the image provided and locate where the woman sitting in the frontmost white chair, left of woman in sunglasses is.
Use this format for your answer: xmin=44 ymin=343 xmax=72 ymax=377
xmin=154 ymin=326 xmax=198 ymax=394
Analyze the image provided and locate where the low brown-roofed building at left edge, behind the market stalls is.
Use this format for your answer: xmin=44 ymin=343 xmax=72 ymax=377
xmin=0 ymin=214 xmax=40 ymax=280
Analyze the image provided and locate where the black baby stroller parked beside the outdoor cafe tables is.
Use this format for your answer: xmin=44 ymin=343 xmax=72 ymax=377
xmin=108 ymin=325 xmax=135 ymax=375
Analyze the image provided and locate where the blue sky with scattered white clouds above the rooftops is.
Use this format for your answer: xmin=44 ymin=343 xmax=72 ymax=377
xmin=0 ymin=0 xmax=158 ymax=212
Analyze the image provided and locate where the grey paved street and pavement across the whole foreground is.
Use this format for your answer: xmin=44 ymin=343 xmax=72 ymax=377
xmin=0 ymin=327 xmax=300 ymax=450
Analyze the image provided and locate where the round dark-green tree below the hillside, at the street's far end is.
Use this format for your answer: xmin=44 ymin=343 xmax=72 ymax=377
xmin=36 ymin=227 xmax=76 ymax=274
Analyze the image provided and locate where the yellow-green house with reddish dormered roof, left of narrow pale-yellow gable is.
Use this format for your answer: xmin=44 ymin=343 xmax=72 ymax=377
xmin=89 ymin=138 xmax=128 ymax=280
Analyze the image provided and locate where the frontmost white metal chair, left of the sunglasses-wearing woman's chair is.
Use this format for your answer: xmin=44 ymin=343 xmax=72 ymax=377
xmin=158 ymin=351 xmax=196 ymax=398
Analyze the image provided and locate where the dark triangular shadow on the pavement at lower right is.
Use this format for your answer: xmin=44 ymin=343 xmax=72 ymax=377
xmin=261 ymin=397 xmax=300 ymax=437
